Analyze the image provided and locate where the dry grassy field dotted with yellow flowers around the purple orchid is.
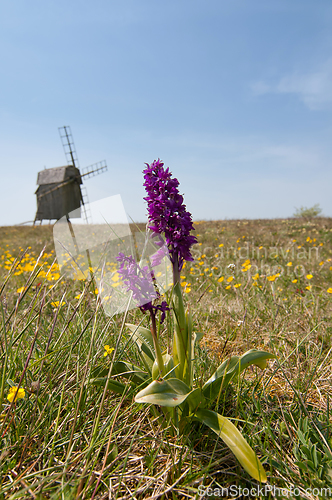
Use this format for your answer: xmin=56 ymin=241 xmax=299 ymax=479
xmin=0 ymin=218 xmax=332 ymax=500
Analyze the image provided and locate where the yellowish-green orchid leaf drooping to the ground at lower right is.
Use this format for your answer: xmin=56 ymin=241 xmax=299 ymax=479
xmin=195 ymin=409 xmax=267 ymax=483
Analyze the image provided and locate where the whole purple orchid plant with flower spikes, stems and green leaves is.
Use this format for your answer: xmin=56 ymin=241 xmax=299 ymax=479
xmin=101 ymin=160 xmax=275 ymax=482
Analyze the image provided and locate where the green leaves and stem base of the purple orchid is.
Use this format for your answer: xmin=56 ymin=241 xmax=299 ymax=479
xmin=100 ymin=256 xmax=276 ymax=482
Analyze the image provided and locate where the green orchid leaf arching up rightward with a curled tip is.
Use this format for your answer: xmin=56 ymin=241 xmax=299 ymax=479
xmin=203 ymin=349 xmax=276 ymax=399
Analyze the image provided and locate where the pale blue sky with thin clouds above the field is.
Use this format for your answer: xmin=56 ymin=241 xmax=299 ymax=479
xmin=0 ymin=0 xmax=332 ymax=225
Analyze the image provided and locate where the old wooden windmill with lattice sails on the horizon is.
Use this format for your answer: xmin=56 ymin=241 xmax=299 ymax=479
xmin=34 ymin=126 xmax=107 ymax=223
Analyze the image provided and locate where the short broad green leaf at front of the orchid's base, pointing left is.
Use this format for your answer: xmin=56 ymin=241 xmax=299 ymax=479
xmin=135 ymin=378 xmax=191 ymax=408
